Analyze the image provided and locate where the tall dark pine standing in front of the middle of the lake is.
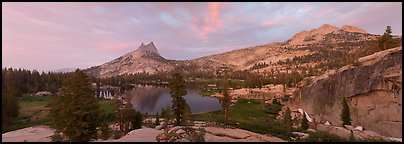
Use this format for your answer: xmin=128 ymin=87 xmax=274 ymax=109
xmin=169 ymin=73 xmax=187 ymax=125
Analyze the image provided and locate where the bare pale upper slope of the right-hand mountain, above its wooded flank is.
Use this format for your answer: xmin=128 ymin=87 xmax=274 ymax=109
xmin=191 ymin=24 xmax=377 ymax=70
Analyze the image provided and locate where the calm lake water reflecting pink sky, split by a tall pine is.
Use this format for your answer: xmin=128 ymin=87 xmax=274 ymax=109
xmin=124 ymin=86 xmax=221 ymax=114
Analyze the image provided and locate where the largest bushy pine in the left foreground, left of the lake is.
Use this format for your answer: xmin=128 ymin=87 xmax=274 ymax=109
xmin=50 ymin=69 xmax=101 ymax=141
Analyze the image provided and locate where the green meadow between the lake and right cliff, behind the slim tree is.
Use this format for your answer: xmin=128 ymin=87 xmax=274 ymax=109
xmin=192 ymin=100 xmax=288 ymax=139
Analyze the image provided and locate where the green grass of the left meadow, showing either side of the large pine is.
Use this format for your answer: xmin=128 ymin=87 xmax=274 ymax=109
xmin=2 ymin=95 xmax=115 ymax=133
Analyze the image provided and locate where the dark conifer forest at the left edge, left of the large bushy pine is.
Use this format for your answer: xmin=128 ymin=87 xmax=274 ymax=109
xmin=1 ymin=68 xmax=69 ymax=127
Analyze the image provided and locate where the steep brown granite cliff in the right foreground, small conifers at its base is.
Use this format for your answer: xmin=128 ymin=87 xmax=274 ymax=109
xmin=288 ymin=47 xmax=402 ymax=138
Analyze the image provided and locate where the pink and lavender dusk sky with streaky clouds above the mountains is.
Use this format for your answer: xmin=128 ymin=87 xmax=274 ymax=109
xmin=2 ymin=2 xmax=403 ymax=71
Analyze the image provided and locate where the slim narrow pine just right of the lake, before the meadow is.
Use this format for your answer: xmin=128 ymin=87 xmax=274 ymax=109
xmin=220 ymin=75 xmax=231 ymax=123
